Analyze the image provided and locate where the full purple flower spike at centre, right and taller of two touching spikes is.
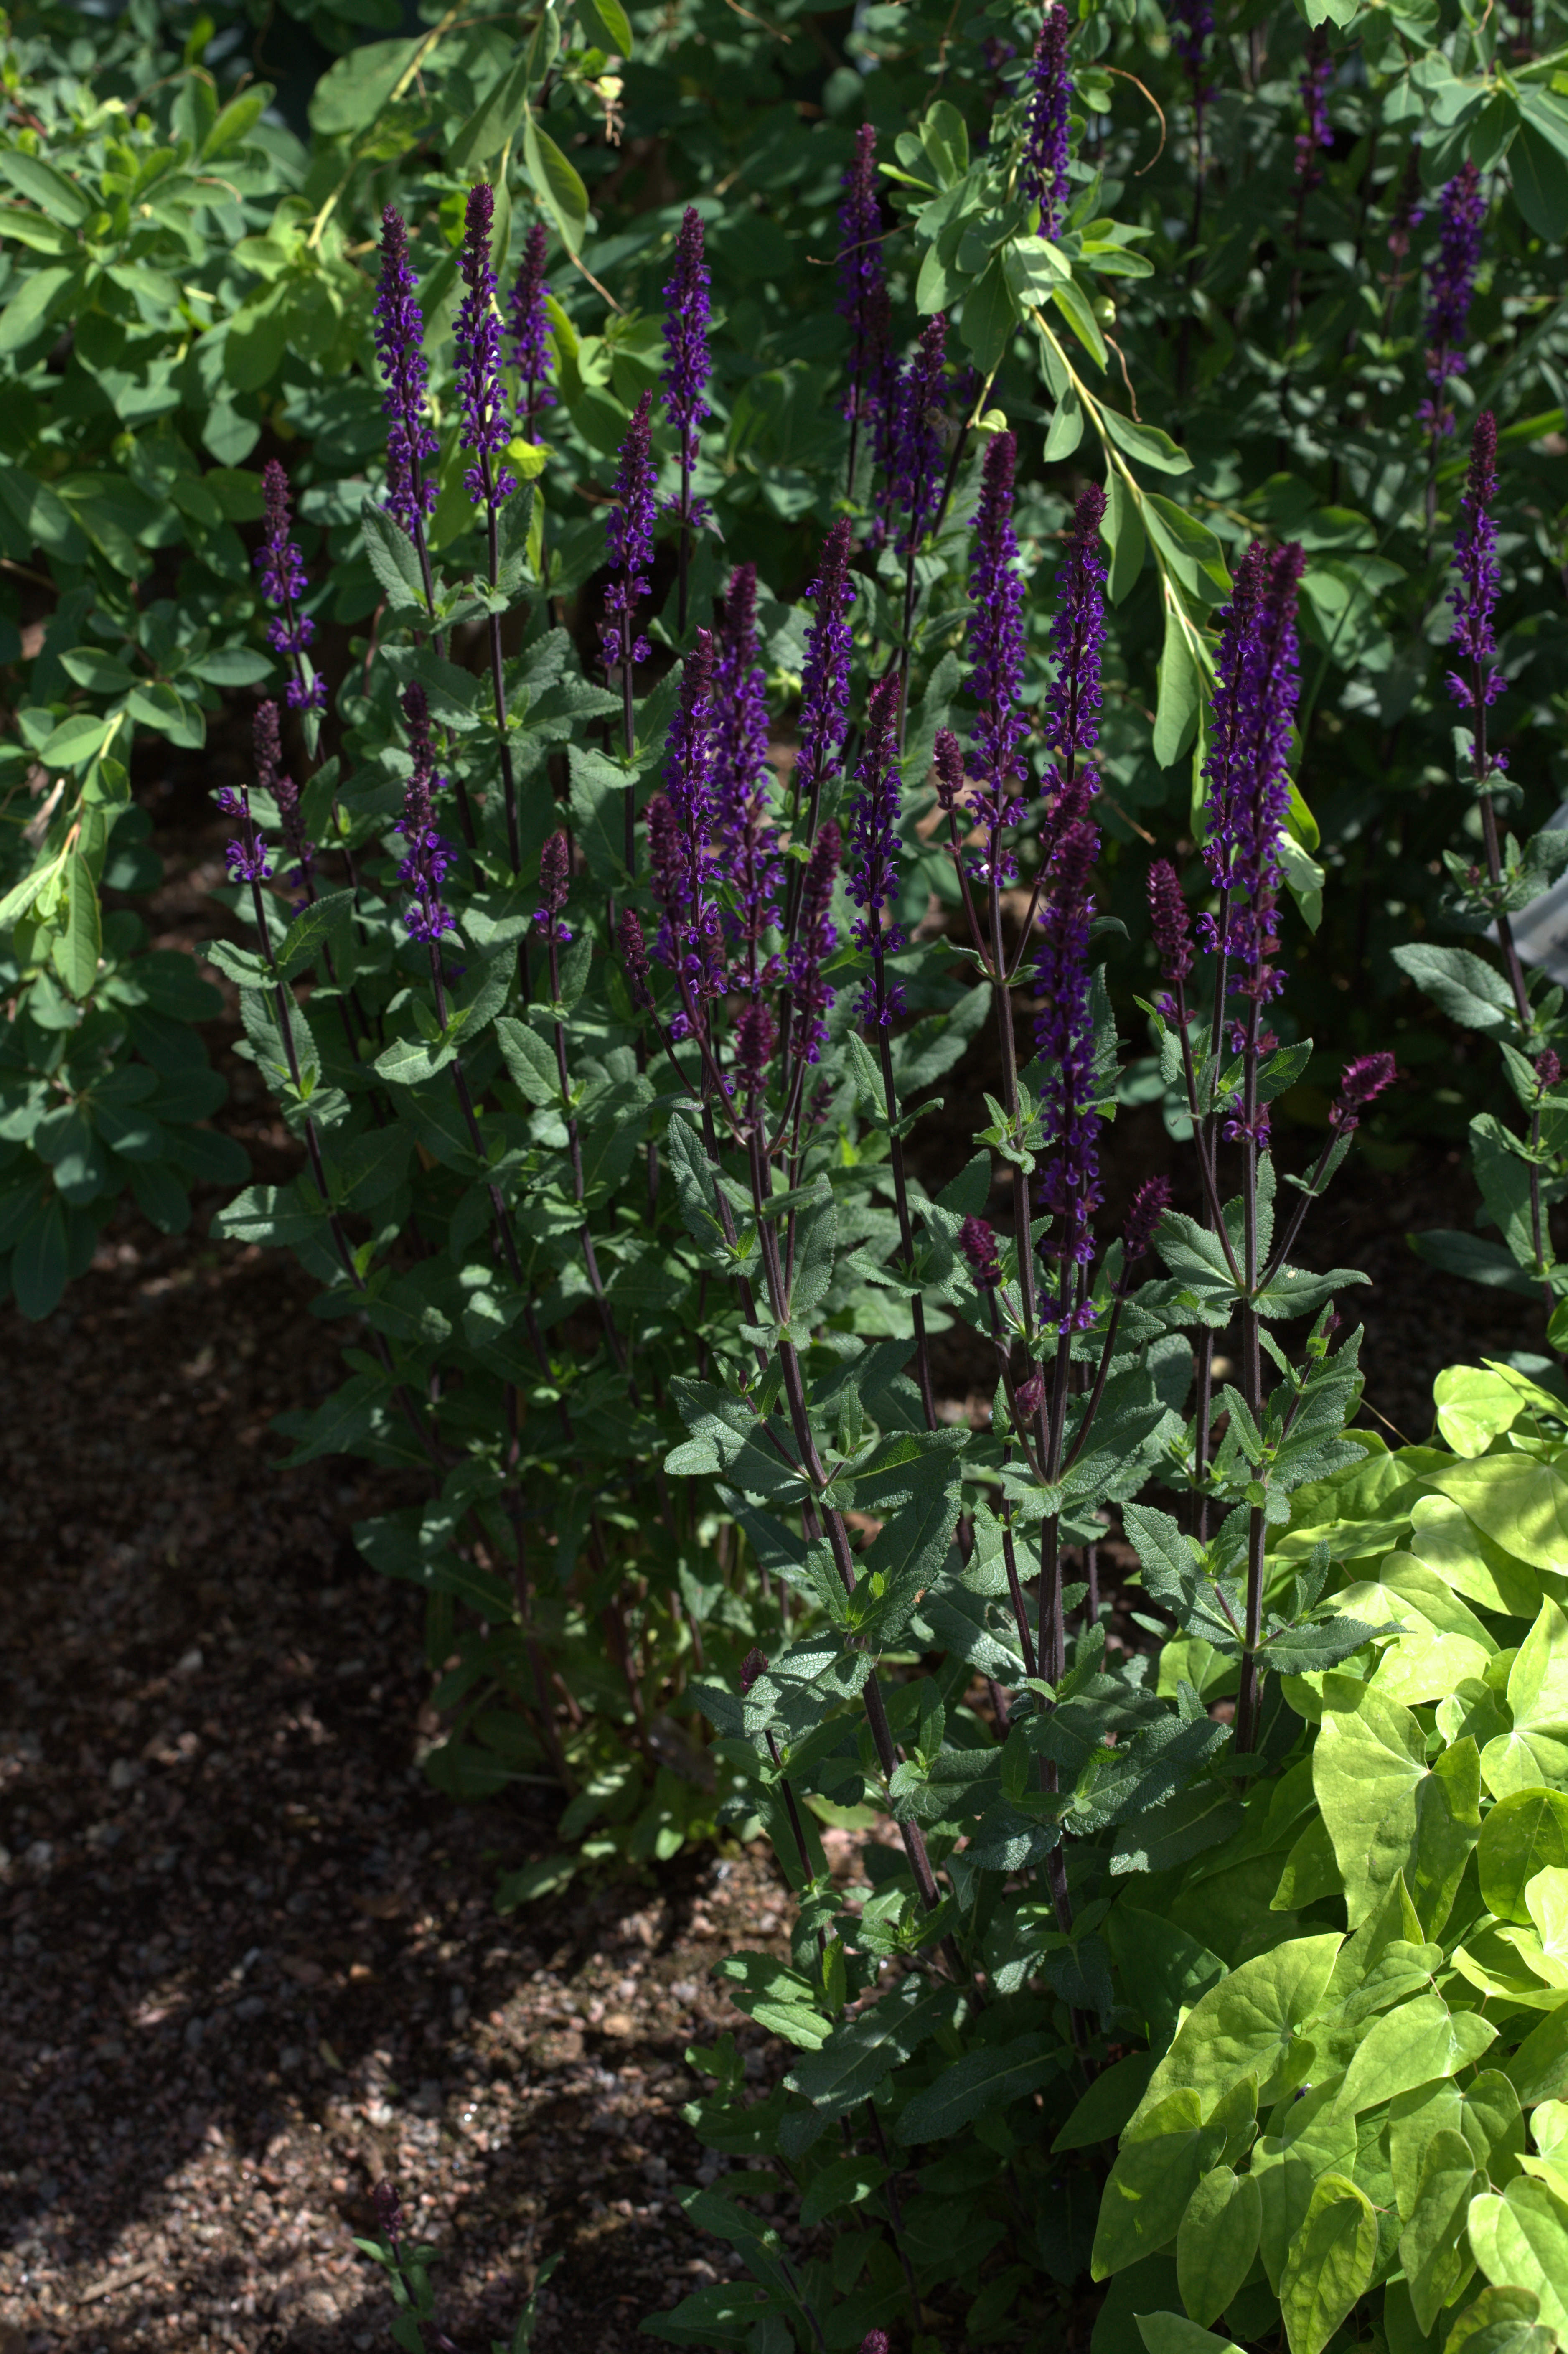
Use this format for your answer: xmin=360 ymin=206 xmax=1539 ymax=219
xmin=713 ymin=565 xmax=784 ymax=989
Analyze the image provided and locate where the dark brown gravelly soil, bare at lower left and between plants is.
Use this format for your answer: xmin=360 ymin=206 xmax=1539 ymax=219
xmin=0 ymin=777 xmax=1540 ymax=2354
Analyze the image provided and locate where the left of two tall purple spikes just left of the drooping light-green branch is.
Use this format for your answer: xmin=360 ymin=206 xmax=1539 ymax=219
xmin=968 ymin=433 xmax=1029 ymax=887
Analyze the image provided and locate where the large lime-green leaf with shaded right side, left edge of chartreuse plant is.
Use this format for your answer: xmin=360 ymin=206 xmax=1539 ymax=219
xmin=1311 ymin=1676 xmax=1481 ymax=1933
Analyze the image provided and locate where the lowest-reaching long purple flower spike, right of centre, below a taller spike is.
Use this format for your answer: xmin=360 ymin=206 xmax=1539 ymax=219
xmin=1034 ymin=817 xmax=1100 ymax=1332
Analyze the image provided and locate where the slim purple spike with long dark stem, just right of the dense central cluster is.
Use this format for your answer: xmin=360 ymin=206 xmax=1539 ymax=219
xmin=850 ymin=676 xmax=937 ymax=1431
